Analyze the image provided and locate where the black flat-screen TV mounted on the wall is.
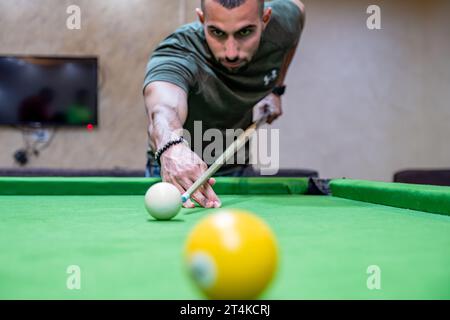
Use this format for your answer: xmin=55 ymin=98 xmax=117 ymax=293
xmin=0 ymin=56 xmax=98 ymax=127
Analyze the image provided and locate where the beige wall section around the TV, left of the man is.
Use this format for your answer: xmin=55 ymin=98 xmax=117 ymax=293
xmin=0 ymin=0 xmax=180 ymax=169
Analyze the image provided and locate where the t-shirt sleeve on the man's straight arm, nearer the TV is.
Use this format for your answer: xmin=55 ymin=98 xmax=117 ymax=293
xmin=143 ymin=42 xmax=196 ymax=92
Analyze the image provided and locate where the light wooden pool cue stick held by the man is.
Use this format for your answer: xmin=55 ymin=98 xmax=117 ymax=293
xmin=181 ymin=115 xmax=268 ymax=203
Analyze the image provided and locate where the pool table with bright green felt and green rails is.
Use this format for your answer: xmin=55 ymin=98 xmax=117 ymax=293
xmin=0 ymin=177 xmax=450 ymax=300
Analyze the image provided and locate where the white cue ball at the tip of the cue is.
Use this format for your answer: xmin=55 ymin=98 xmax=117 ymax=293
xmin=145 ymin=182 xmax=181 ymax=220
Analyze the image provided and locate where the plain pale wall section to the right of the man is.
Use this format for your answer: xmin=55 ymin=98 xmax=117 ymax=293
xmin=284 ymin=0 xmax=450 ymax=180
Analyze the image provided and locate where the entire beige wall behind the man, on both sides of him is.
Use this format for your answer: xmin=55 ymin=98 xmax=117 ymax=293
xmin=0 ymin=0 xmax=450 ymax=180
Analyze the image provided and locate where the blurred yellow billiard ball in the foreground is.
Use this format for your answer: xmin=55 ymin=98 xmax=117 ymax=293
xmin=185 ymin=209 xmax=278 ymax=300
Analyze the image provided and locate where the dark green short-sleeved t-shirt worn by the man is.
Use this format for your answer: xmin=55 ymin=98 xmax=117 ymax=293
xmin=144 ymin=0 xmax=304 ymax=169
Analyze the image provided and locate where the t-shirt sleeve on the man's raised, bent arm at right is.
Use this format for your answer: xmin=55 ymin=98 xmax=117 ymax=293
xmin=265 ymin=0 xmax=305 ymax=48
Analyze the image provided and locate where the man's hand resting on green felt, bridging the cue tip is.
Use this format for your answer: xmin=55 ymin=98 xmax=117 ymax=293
xmin=161 ymin=144 xmax=221 ymax=208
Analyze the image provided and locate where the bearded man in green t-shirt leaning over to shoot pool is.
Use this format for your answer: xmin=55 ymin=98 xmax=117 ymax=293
xmin=144 ymin=0 xmax=304 ymax=208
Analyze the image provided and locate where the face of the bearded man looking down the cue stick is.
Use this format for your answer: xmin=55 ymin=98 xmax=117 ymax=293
xmin=197 ymin=0 xmax=271 ymax=72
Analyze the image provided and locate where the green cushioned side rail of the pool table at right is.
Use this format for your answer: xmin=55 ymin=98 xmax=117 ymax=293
xmin=330 ymin=179 xmax=450 ymax=215
